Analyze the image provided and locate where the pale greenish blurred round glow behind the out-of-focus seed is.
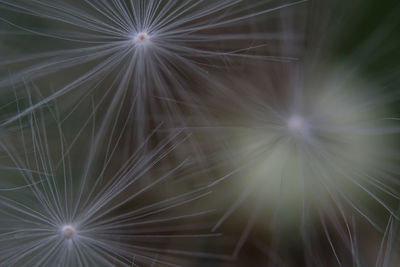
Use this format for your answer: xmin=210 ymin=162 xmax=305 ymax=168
xmin=221 ymin=67 xmax=398 ymax=238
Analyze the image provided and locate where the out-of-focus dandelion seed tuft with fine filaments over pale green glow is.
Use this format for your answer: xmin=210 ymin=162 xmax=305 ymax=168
xmin=199 ymin=62 xmax=400 ymax=265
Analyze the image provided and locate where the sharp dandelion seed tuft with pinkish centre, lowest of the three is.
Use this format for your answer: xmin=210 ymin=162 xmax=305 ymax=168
xmin=0 ymin=95 xmax=222 ymax=266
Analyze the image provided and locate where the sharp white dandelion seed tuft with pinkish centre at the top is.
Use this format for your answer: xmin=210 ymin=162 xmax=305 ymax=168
xmin=0 ymin=0 xmax=306 ymax=140
